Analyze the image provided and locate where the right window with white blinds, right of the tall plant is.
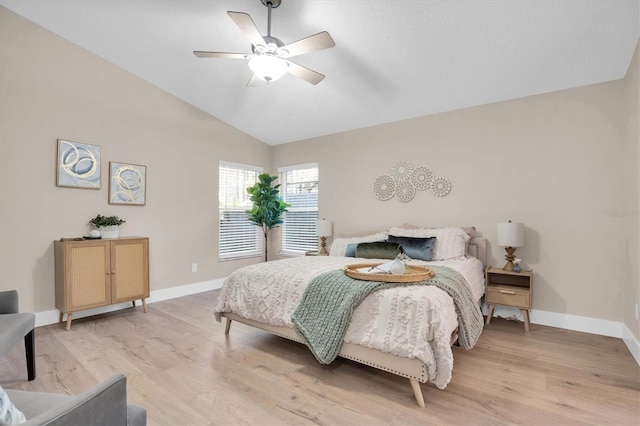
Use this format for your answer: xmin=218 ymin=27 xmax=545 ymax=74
xmin=278 ymin=163 xmax=318 ymax=254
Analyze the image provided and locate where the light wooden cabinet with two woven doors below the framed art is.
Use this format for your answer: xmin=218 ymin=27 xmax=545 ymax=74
xmin=54 ymin=237 xmax=149 ymax=330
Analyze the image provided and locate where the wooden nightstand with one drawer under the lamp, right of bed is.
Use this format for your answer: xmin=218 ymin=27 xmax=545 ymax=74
xmin=484 ymin=266 xmax=533 ymax=332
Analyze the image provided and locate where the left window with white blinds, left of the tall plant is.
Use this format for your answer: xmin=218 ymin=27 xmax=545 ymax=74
xmin=218 ymin=161 xmax=264 ymax=260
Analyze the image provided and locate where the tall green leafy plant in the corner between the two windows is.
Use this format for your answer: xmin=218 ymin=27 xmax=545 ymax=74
xmin=245 ymin=173 xmax=291 ymax=262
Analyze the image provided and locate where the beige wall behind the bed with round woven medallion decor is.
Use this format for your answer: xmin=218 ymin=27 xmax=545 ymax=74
xmin=273 ymin=69 xmax=638 ymax=321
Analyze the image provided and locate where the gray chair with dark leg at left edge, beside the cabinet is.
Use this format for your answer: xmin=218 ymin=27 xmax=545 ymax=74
xmin=0 ymin=290 xmax=36 ymax=380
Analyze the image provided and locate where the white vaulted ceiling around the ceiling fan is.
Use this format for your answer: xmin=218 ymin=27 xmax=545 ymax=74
xmin=0 ymin=0 xmax=640 ymax=145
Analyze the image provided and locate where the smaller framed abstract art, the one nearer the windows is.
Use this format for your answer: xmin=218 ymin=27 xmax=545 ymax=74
xmin=109 ymin=161 xmax=147 ymax=206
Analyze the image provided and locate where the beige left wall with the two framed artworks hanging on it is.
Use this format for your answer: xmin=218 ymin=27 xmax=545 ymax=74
xmin=0 ymin=7 xmax=270 ymax=312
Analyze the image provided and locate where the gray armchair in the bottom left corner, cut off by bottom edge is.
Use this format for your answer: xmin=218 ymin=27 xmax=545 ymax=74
xmin=5 ymin=374 xmax=147 ymax=426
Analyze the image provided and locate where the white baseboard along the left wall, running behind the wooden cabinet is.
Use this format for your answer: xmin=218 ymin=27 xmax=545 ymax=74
xmin=36 ymin=278 xmax=224 ymax=327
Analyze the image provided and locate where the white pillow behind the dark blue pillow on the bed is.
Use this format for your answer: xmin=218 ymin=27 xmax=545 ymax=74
xmin=389 ymin=227 xmax=471 ymax=260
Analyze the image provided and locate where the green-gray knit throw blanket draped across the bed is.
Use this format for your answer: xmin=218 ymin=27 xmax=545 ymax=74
xmin=291 ymin=266 xmax=483 ymax=364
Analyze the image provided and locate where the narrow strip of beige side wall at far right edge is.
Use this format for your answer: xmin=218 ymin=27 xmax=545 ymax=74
xmin=619 ymin=43 xmax=640 ymax=340
